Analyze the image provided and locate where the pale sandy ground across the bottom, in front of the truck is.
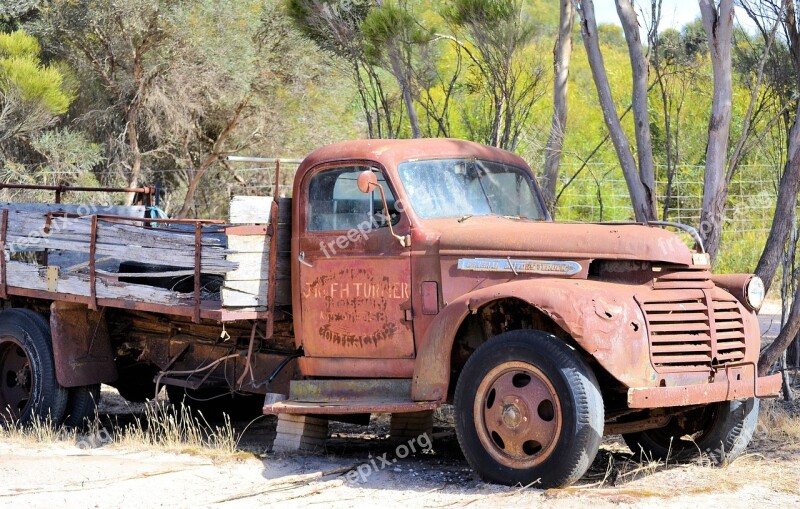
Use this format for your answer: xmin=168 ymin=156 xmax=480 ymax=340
xmin=0 ymin=430 xmax=800 ymax=508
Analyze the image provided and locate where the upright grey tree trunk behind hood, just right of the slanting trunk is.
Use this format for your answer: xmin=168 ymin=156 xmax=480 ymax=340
xmin=617 ymin=0 xmax=657 ymax=216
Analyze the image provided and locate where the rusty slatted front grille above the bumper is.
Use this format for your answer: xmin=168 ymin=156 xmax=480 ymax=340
xmin=637 ymin=272 xmax=745 ymax=371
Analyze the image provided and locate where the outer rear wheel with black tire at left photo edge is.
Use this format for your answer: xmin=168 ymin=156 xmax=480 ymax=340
xmin=0 ymin=309 xmax=68 ymax=425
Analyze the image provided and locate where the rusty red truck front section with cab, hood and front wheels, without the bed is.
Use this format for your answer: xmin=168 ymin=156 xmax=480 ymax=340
xmin=265 ymin=139 xmax=780 ymax=486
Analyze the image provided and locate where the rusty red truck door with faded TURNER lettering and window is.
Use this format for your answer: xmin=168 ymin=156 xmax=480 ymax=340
xmin=296 ymin=165 xmax=415 ymax=359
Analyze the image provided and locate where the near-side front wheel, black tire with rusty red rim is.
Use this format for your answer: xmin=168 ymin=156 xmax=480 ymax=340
xmin=454 ymin=330 xmax=604 ymax=488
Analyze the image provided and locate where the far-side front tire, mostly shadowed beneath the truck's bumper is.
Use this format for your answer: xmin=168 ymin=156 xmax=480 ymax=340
xmin=622 ymin=398 xmax=759 ymax=464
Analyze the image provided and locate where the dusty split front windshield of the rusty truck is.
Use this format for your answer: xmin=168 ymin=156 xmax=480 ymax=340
xmin=398 ymin=159 xmax=546 ymax=219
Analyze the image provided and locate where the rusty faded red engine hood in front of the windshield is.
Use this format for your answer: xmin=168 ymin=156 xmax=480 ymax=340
xmin=425 ymin=216 xmax=692 ymax=266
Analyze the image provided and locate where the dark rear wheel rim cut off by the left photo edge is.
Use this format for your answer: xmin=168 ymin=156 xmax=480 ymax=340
xmin=0 ymin=337 xmax=33 ymax=419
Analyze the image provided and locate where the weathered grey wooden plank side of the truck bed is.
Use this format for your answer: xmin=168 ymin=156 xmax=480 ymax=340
xmin=0 ymin=194 xmax=291 ymax=322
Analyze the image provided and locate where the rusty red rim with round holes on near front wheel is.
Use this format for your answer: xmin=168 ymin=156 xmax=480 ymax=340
xmin=473 ymin=362 xmax=562 ymax=469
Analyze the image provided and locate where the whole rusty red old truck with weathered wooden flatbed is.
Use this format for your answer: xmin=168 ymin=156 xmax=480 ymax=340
xmin=0 ymin=139 xmax=780 ymax=486
